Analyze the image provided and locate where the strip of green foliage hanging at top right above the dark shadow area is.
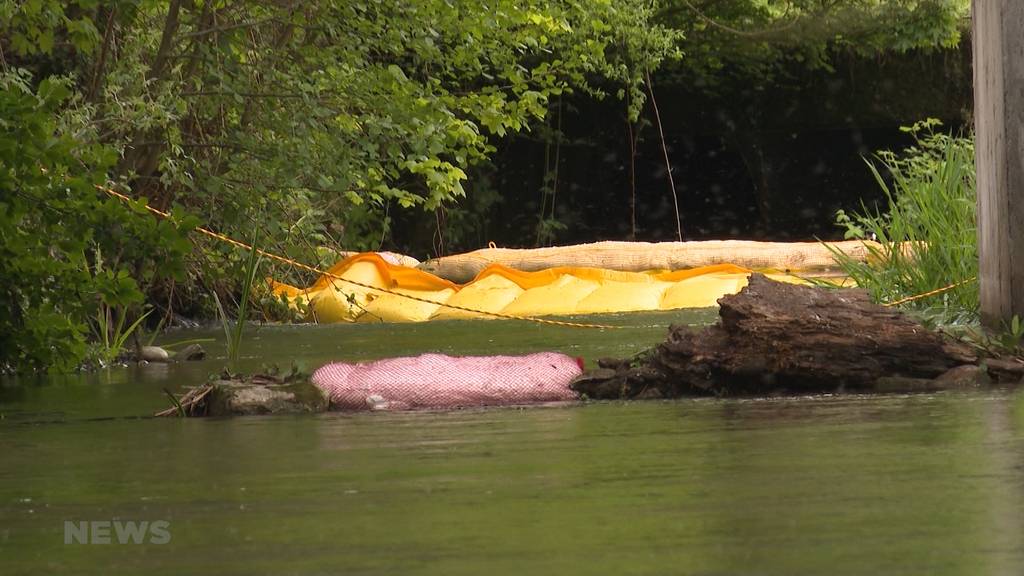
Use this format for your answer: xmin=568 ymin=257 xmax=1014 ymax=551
xmin=655 ymin=0 xmax=971 ymax=85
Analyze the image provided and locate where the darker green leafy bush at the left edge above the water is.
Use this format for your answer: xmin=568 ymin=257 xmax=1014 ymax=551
xmin=0 ymin=73 xmax=190 ymax=370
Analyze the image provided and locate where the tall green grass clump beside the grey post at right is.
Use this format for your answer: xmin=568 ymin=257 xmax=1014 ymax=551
xmin=834 ymin=120 xmax=979 ymax=324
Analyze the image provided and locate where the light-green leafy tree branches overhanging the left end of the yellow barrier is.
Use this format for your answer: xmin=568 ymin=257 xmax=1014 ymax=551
xmin=0 ymin=0 xmax=679 ymax=313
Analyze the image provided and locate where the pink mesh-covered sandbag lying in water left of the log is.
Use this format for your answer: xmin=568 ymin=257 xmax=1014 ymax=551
xmin=312 ymin=352 xmax=583 ymax=410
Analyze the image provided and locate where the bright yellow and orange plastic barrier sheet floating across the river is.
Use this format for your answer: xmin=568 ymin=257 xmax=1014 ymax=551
xmin=272 ymin=253 xmax=802 ymax=323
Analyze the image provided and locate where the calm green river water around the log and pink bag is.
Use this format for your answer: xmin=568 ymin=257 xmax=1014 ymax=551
xmin=0 ymin=311 xmax=1024 ymax=576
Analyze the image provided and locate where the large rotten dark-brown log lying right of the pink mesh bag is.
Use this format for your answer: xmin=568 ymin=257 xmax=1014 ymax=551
xmin=573 ymin=275 xmax=987 ymax=398
